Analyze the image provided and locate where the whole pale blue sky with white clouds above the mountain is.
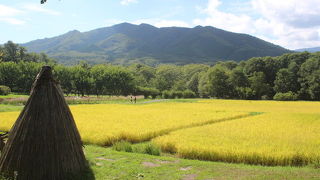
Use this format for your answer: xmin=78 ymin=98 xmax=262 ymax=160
xmin=0 ymin=0 xmax=320 ymax=49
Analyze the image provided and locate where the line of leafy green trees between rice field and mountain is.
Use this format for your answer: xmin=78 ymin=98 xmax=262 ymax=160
xmin=0 ymin=42 xmax=320 ymax=100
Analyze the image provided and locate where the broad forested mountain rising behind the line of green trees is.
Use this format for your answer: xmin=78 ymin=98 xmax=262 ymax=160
xmin=22 ymin=23 xmax=291 ymax=64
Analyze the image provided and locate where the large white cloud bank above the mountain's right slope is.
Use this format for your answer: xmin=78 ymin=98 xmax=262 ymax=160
xmin=193 ymin=0 xmax=320 ymax=49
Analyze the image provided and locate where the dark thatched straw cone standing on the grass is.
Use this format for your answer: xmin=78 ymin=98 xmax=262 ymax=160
xmin=0 ymin=66 xmax=87 ymax=180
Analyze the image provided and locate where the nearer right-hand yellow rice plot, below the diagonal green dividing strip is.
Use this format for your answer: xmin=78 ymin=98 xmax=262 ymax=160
xmin=153 ymin=112 xmax=320 ymax=166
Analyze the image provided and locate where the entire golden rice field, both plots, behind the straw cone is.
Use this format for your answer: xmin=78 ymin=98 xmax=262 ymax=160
xmin=0 ymin=100 xmax=320 ymax=165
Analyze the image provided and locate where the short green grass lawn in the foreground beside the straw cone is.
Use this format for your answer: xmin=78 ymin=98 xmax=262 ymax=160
xmin=85 ymin=145 xmax=320 ymax=180
